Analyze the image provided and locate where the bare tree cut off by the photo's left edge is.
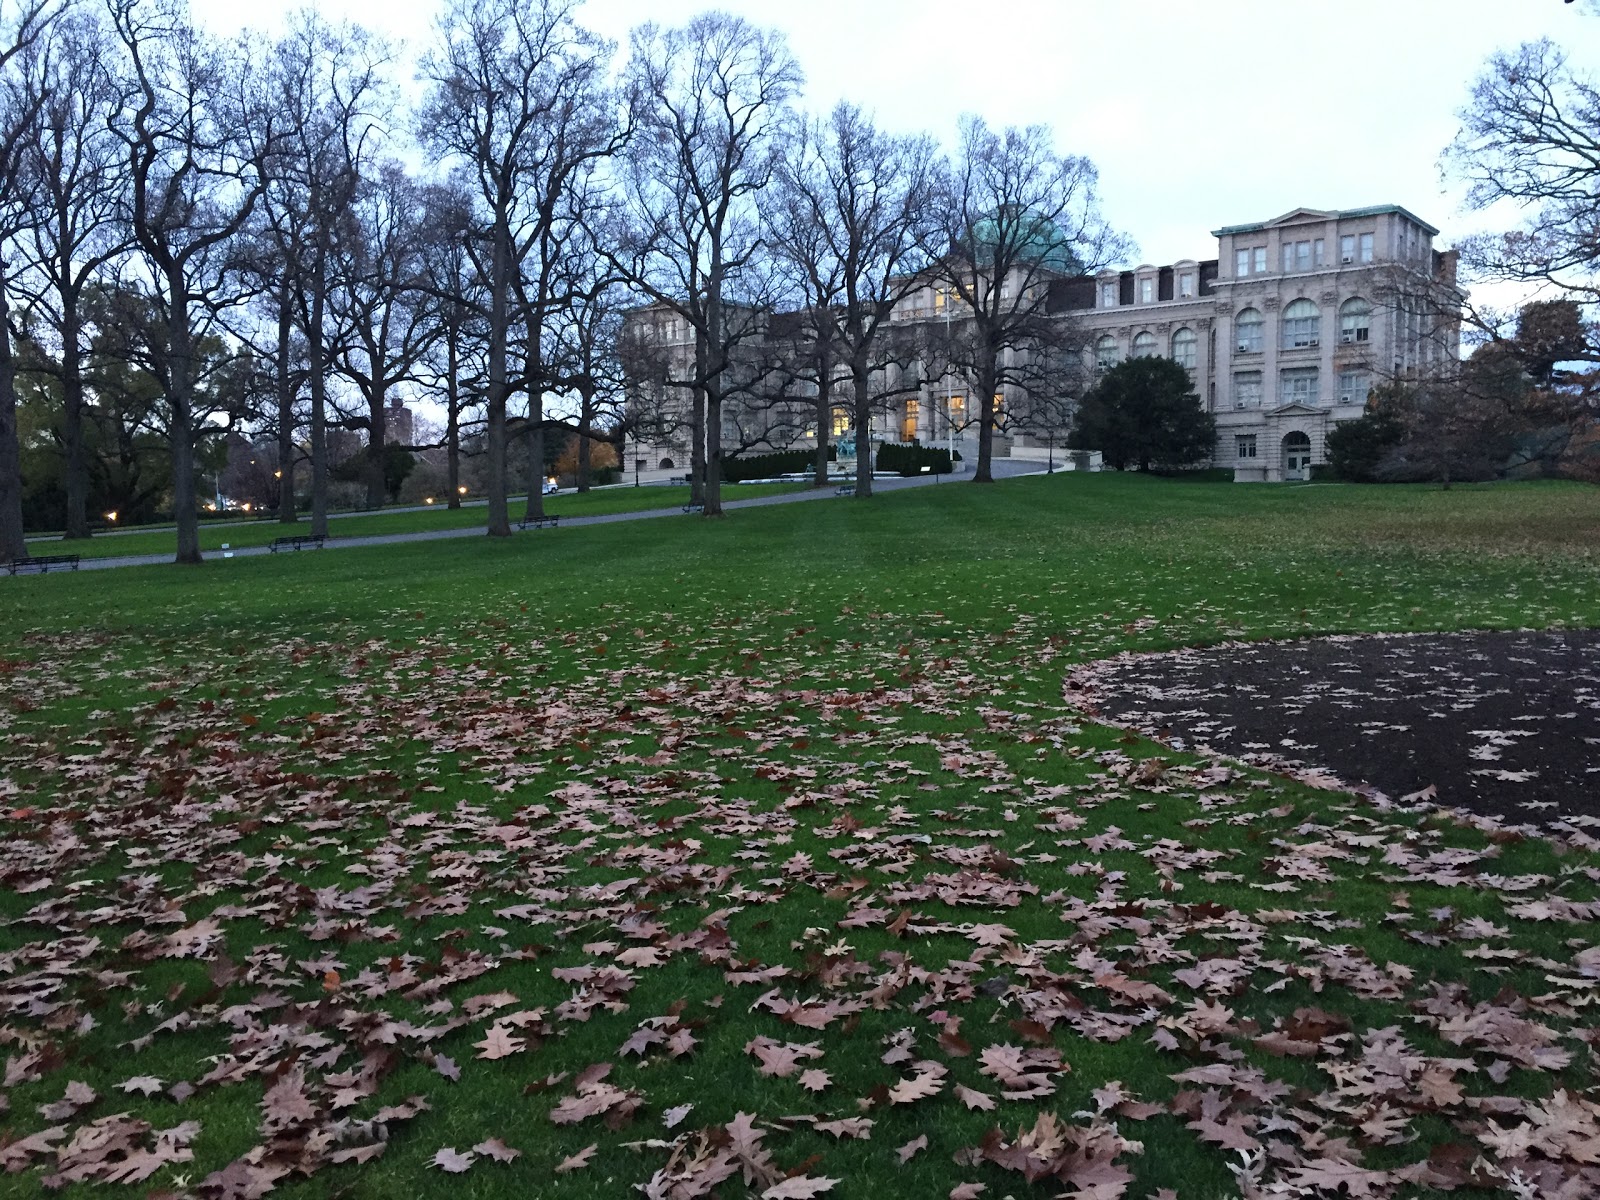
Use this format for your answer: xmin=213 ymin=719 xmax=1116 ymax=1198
xmin=0 ymin=0 xmax=61 ymax=562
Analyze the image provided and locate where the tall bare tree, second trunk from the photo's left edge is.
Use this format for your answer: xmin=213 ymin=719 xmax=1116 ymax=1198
xmin=21 ymin=10 xmax=128 ymax=538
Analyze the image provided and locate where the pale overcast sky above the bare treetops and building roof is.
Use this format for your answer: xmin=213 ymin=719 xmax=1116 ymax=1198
xmin=192 ymin=0 xmax=1600 ymax=266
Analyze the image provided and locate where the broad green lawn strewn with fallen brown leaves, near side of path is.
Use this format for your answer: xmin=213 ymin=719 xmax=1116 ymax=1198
xmin=0 ymin=475 xmax=1600 ymax=1200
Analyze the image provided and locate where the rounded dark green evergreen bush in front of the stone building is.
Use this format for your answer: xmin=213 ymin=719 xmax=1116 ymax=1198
xmin=1067 ymin=358 xmax=1216 ymax=470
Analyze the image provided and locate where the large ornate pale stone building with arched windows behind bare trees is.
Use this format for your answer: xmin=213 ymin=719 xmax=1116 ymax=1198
xmin=629 ymin=205 xmax=1459 ymax=480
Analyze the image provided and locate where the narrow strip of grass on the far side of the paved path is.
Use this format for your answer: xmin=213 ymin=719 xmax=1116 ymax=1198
xmin=18 ymin=483 xmax=806 ymax=558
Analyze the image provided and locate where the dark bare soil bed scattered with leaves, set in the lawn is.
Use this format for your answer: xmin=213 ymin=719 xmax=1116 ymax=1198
xmin=1067 ymin=630 xmax=1600 ymax=822
